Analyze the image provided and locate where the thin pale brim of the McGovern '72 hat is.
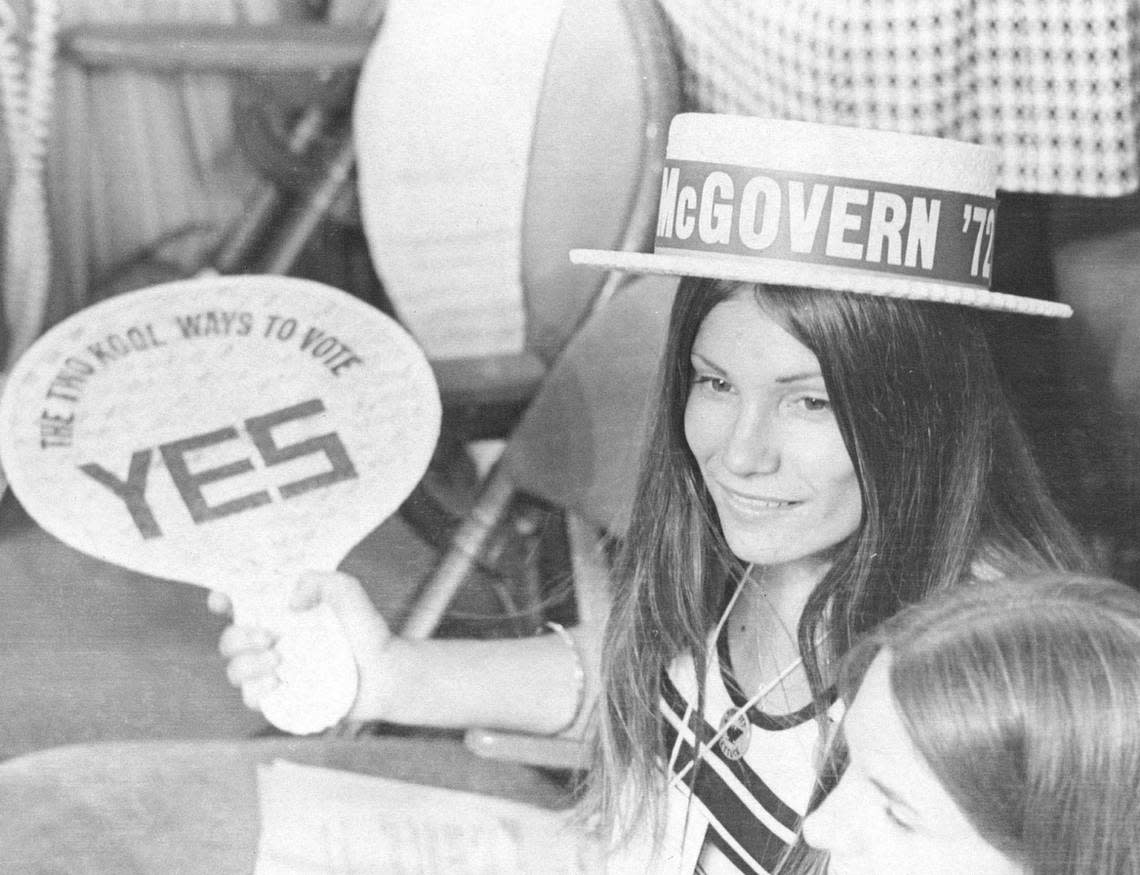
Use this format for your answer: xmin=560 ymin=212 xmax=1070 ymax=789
xmin=570 ymin=250 xmax=1073 ymax=319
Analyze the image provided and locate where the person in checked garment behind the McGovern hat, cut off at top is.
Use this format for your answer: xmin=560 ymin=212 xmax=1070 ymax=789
xmin=660 ymin=0 xmax=1140 ymax=569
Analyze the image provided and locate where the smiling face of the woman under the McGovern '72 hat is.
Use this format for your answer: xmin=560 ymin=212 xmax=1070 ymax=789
xmin=685 ymin=296 xmax=863 ymax=574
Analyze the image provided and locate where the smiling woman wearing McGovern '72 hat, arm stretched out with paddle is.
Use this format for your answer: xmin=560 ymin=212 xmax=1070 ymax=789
xmin=222 ymin=115 xmax=1084 ymax=873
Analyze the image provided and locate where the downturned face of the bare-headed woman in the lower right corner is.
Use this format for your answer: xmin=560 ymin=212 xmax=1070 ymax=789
xmin=804 ymin=652 xmax=1024 ymax=875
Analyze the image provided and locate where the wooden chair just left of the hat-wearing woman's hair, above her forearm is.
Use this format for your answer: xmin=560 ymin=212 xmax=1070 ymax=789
xmin=466 ymin=271 xmax=677 ymax=769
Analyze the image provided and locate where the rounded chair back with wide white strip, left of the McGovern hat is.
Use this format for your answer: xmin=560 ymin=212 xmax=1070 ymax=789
xmin=353 ymin=0 xmax=679 ymax=361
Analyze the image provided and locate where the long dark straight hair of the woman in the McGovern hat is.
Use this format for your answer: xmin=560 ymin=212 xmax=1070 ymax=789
xmin=586 ymin=278 xmax=1085 ymax=832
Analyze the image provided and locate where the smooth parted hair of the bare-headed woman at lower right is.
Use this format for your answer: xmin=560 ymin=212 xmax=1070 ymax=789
xmin=839 ymin=574 xmax=1140 ymax=875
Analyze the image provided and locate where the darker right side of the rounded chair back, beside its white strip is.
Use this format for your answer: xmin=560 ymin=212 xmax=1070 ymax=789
xmin=521 ymin=0 xmax=681 ymax=362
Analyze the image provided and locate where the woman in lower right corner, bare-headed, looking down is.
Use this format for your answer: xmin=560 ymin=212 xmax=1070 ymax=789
xmin=804 ymin=574 xmax=1140 ymax=875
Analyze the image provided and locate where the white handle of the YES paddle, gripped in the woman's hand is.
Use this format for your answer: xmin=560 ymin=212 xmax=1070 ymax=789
xmin=234 ymin=602 xmax=359 ymax=735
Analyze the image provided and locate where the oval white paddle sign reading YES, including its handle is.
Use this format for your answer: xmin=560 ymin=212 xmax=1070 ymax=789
xmin=0 ymin=277 xmax=440 ymax=733
